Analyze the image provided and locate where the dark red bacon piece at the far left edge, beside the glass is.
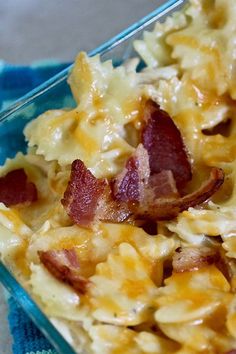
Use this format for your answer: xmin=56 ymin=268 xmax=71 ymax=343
xmin=0 ymin=168 xmax=38 ymax=207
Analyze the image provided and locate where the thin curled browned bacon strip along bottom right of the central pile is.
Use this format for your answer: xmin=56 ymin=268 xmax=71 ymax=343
xmin=135 ymin=167 xmax=224 ymax=220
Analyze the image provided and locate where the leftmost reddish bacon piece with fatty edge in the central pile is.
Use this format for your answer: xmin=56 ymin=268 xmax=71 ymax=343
xmin=61 ymin=160 xmax=131 ymax=227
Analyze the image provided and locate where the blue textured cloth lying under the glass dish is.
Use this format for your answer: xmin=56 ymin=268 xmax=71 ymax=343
xmin=0 ymin=61 xmax=69 ymax=354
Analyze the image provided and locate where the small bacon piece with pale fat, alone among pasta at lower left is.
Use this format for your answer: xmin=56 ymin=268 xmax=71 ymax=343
xmin=38 ymin=248 xmax=89 ymax=294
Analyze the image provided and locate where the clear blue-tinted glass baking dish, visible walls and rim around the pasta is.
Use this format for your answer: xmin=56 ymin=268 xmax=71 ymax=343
xmin=0 ymin=0 xmax=186 ymax=354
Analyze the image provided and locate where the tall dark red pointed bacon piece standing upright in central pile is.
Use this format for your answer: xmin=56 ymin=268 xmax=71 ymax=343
xmin=142 ymin=100 xmax=192 ymax=189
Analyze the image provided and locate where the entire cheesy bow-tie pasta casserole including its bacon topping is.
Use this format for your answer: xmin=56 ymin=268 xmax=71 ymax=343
xmin=0 ymin=0 xmax=236 ymax=354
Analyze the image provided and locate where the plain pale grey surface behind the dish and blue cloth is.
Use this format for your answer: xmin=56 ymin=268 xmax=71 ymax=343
xmin=0 ymin=0 xmax=165 ymax=354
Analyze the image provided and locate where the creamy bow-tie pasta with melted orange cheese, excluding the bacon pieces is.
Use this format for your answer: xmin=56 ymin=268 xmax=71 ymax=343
xmin=0 ymin=0 xmax=236 ymax=354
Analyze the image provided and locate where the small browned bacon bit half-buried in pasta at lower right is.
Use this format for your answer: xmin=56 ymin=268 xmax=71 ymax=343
xmin=172 ymin=247 xmax=220 ymax=273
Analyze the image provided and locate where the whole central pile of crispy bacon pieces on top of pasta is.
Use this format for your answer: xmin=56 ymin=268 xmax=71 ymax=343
xmin=61 ymin=101 xmax=224 ymax=227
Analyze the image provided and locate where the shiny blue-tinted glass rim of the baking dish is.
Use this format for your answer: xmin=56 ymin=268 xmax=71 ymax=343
xmin=0 ymin=0 xmax=186 ymax=354
